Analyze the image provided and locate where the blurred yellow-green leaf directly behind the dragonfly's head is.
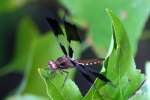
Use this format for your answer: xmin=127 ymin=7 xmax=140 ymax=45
xmin=15 ymin=33 xmax=81 ymax=96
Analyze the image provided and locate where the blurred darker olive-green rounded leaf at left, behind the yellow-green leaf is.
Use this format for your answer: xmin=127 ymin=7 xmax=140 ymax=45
xmin=15 ymin=17 xmax=39 ymax=59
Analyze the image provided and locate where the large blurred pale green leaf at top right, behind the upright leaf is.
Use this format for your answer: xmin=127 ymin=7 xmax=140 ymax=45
xmin=60 ymin=0 xmax=150 ymax=56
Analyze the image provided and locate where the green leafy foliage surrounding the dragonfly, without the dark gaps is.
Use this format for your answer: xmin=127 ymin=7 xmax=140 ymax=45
xmin=0 ymin=0 xmax=150 ymax=100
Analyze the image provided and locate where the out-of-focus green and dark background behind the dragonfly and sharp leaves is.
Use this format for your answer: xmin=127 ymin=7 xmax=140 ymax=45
xmin=0 ymin=0 xmax=150 ymax=99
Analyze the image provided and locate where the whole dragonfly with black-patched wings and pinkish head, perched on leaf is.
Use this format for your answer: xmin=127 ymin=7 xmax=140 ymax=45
xmin=47 ymin=18 xmax=110 ymax=83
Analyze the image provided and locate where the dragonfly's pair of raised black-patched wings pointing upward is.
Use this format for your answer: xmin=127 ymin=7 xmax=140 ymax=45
xmin=47 ymin=18 xmax=81 ymax=58
